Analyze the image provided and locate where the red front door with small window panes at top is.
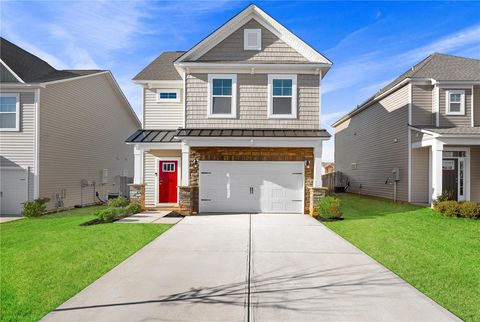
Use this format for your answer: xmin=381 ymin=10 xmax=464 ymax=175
xmin=158 ymin=161 xmax=178 ymax=203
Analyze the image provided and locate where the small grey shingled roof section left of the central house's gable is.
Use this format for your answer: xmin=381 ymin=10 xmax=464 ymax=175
xmin=133 ymin=51 xmax=185 ymax=81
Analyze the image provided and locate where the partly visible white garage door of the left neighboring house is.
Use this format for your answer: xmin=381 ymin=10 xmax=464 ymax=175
xmin=0 ymin=169 xmax=27 ymax=215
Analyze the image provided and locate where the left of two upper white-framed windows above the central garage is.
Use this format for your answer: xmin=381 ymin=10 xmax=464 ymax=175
xmin=208 ymin=74 xmax=237 ymax=118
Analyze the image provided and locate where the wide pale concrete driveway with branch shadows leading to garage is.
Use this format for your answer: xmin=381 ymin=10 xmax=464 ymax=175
xmin=44 ymin=214 xmax=458 ymax=321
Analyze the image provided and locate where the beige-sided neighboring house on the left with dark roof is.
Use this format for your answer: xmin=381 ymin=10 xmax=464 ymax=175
xmin=0 ymin=38 xmax=140 ymax=214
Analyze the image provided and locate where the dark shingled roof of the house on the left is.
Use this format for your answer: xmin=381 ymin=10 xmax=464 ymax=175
xmin=0 ymin=37 xmax=103 ymax=83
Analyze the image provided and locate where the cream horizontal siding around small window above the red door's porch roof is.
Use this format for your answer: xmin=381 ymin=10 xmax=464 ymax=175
xmin=143 ymin=88 xmax=183 ymax=129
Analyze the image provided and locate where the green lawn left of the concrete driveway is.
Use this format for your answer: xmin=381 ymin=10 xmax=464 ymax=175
xmin=0 ymin=207 xmax=171 ymax=321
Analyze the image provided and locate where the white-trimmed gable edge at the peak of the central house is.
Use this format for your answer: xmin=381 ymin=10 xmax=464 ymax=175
xmin=176 ymin=4 xmax=332 ymax=65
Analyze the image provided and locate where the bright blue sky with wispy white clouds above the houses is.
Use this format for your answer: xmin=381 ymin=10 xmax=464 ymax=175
xmin=0 ymin=0 xmax=480 ymax=160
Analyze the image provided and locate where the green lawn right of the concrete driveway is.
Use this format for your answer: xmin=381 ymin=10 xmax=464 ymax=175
xmin=324 ymin=194 xmax=480 ymax=321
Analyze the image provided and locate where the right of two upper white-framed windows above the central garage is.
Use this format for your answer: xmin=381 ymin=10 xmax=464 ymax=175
xmin=268 ymin=75 xmax=297 ymax=118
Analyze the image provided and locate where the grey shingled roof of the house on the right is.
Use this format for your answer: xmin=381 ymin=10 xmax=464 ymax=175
xmin=332 ymin=53 xmax=480 ymax=127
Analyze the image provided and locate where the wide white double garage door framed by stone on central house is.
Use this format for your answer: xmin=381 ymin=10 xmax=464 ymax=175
xmin=199 ymin=161 xmax=304 ymax=213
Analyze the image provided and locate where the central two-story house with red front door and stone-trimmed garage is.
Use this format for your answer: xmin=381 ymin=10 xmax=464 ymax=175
xmin=127 ymin=5 xmax=332 ymax=213
